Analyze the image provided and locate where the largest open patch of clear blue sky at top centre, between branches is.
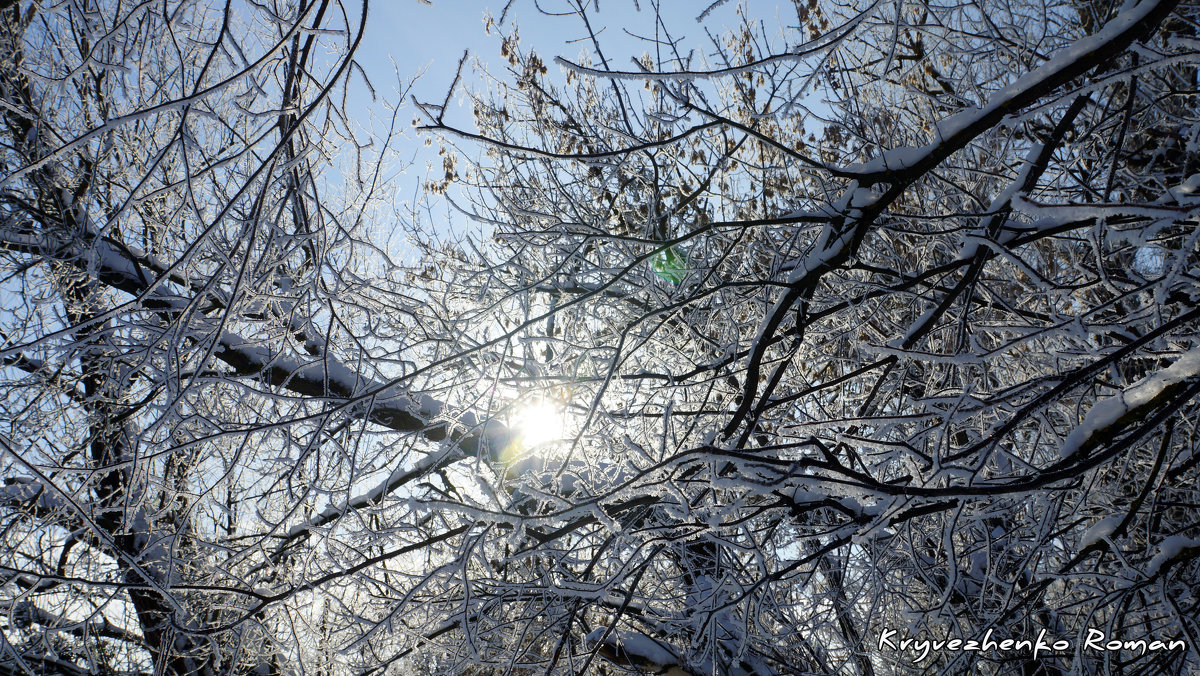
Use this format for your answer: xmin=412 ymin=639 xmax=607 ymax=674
xmin=336 ymin=0 xmax=796 ymax=258
